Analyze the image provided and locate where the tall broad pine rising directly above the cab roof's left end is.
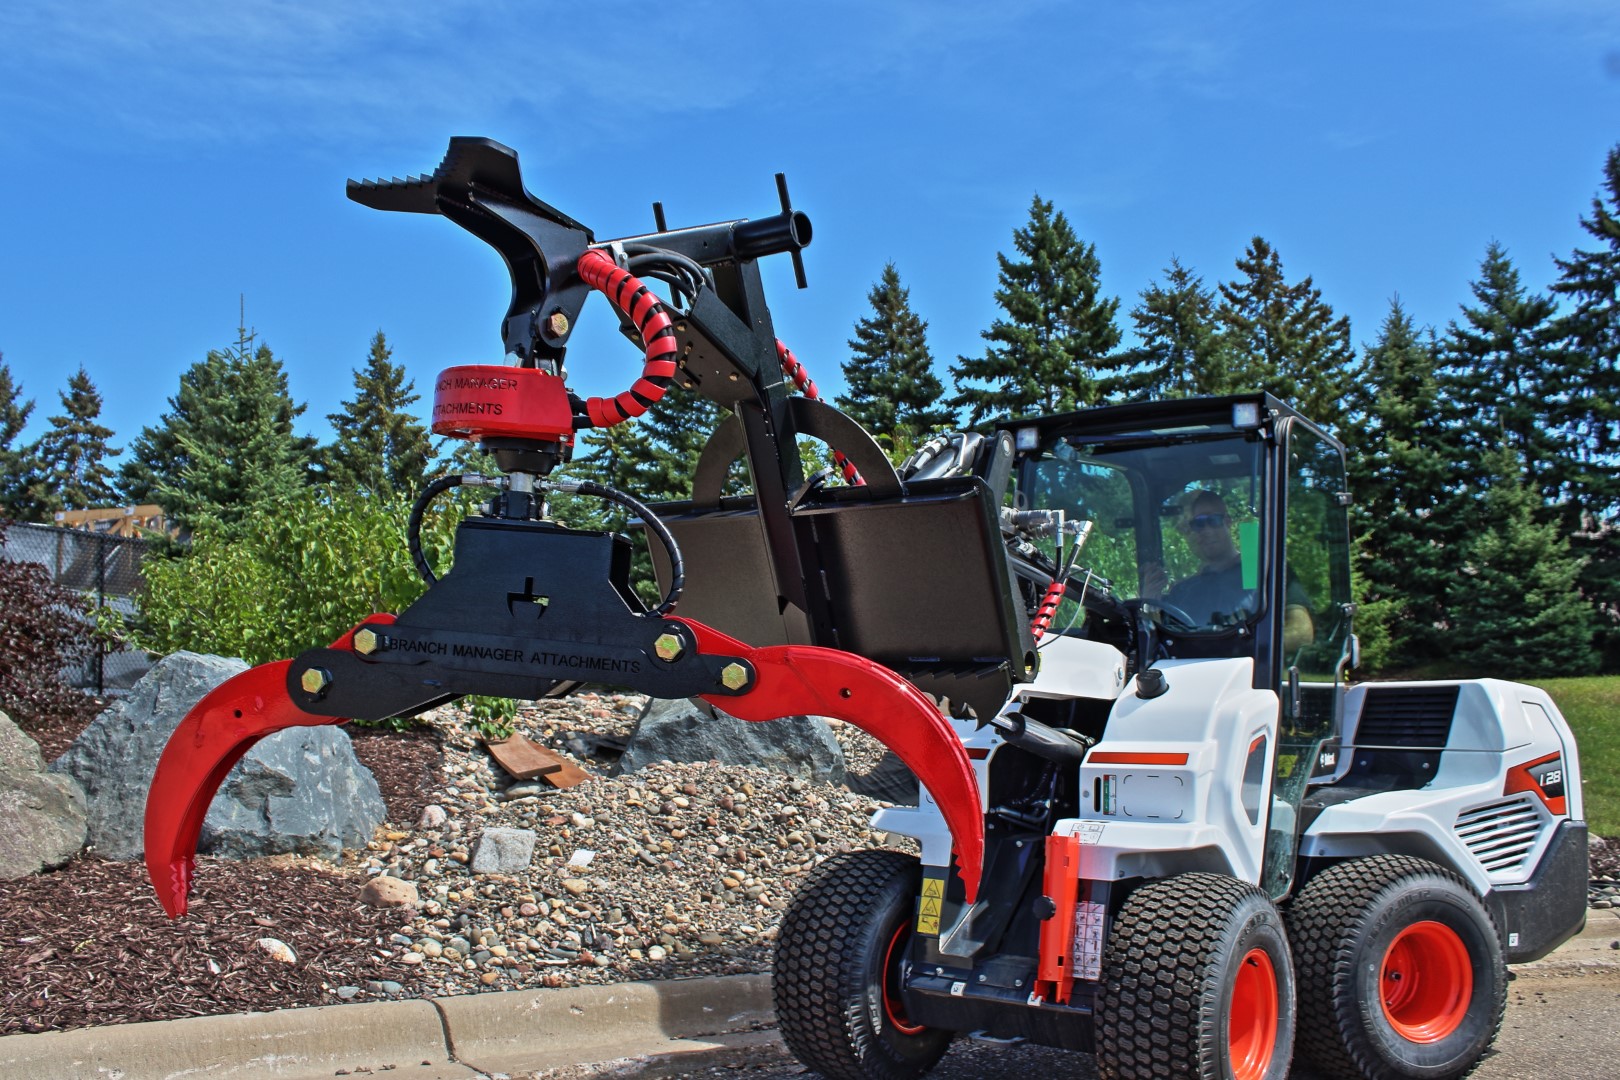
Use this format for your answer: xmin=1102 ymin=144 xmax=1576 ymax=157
xmin=949 ymin=194 xmax=1124 ymax=424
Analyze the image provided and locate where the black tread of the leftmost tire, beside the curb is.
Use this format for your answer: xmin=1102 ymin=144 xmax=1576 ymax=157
xmin=771 ymin=850 xmax=951 ymax=1080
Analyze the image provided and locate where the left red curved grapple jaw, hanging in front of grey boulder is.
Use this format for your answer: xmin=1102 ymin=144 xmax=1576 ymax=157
xmin=146 ymin=617 xmax=382 ymax=918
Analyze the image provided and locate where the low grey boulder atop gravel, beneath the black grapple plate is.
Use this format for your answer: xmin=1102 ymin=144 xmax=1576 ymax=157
xmin=619 ymin=698 xmax=844 ymax=784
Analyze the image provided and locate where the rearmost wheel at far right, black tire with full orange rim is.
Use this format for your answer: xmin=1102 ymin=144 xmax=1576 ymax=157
xmin=1288 ymin=855 xmax=1508 ymax=1080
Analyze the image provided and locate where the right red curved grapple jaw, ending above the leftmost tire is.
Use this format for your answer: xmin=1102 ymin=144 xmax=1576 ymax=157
xmin=680 ymin=619 xmax=985 ymax=904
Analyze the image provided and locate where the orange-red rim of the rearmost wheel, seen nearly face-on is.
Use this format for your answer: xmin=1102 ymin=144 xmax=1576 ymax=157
xmin=1379 ymin=920 xmax=1474 ymax=1043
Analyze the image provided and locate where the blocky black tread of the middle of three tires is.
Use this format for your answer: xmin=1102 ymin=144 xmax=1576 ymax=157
xmin=1097 ymin=873 xmax=1264 ymax=1080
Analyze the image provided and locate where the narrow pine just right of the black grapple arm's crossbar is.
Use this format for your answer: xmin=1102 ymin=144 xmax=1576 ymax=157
xmin=838 ymin=262 xmax=956 ymax=436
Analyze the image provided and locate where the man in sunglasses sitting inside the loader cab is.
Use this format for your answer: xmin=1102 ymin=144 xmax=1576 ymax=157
xmin=1142 ymin=491 xmax=1315 ymax=653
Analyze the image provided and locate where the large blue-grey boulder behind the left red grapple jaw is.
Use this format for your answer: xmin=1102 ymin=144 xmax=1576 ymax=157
xmin=50 ymin=653 xmax=387 ymax=858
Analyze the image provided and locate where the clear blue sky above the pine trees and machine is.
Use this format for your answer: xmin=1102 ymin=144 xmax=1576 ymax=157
xmin=0 ymin=0 xmax=1620 ymax=459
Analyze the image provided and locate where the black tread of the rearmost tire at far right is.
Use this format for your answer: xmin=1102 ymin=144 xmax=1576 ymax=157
xmin=1283 ymin=855 xmax=1507 ymax=1080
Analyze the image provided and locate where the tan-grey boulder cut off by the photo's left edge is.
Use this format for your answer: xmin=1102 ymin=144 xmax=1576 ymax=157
xmin=0 ymin=712 xmax=86 ymax=881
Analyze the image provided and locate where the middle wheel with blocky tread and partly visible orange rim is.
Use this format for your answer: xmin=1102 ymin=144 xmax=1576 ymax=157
xmin=1097 ymin=874 xmax=1294 ymax=1080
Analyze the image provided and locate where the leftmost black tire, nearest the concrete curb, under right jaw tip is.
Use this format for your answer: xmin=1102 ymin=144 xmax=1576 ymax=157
xmin=771 ymin=852 xmax=953 ymax=1080
